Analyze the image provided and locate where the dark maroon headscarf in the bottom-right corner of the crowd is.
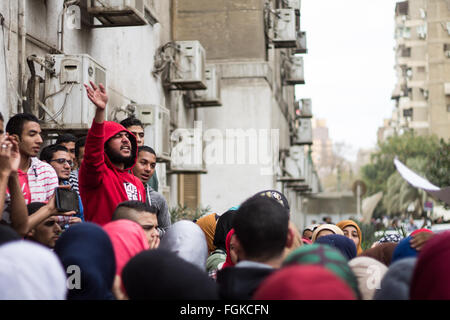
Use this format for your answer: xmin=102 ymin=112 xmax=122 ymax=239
xmin=410 ymin=231 xmax=450 ymax=300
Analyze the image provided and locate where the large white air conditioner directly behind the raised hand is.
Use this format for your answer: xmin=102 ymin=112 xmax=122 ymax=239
xmin=41 ymin=54 xmax=108 ymax=130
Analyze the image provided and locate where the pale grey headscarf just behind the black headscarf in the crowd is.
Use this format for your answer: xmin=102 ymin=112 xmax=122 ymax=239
xmin=159 ymin=220 xmax=208 ymax=271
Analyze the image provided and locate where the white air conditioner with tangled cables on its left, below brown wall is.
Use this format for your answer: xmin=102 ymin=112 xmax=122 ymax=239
xmin=169 ymin=41 xmax=206 ymax=90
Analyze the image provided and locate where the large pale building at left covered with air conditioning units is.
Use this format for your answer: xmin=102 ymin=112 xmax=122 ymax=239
xmin=0 ymin=0 xmax=319 ymax=227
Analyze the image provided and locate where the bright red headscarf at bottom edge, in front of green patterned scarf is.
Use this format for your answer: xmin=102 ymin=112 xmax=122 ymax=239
xmin=253 ymin=265 xmax=356 ymax=300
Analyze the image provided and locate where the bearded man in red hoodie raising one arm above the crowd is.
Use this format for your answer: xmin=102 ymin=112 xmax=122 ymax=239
xmin=79 ymin=82 xmax=145 ymax=225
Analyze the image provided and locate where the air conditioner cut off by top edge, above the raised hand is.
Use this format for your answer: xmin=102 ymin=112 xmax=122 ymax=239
xmin=85 ymin=0 xmax=148 ymax=27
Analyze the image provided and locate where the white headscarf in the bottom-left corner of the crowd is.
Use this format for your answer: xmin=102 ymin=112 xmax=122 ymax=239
xmin=0 ymin=240 xmax=67 ymax=300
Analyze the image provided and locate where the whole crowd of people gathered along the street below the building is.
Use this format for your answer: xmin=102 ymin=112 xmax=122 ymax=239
xmin=0 ymin=83 xmax=450 ymax=300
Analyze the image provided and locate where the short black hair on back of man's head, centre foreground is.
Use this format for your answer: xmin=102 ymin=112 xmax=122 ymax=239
xmin=233 ymin=197 xmax=289 ymax=261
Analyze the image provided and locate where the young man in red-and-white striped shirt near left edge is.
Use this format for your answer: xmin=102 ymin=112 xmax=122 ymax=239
xmin=3 ymin=113 xmax=58 ymax=216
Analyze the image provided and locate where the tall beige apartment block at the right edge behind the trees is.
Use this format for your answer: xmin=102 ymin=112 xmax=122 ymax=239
xmin=390 ymin=0 xmax=450 ymax=139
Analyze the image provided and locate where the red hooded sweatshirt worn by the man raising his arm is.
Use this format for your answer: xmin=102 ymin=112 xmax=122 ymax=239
xmin=78 ymin=121 xmax=145 ymax=225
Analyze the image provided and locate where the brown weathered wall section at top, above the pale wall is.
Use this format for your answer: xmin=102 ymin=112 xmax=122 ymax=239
xmin=174 ymin=0 xmax=265 ymax=60
